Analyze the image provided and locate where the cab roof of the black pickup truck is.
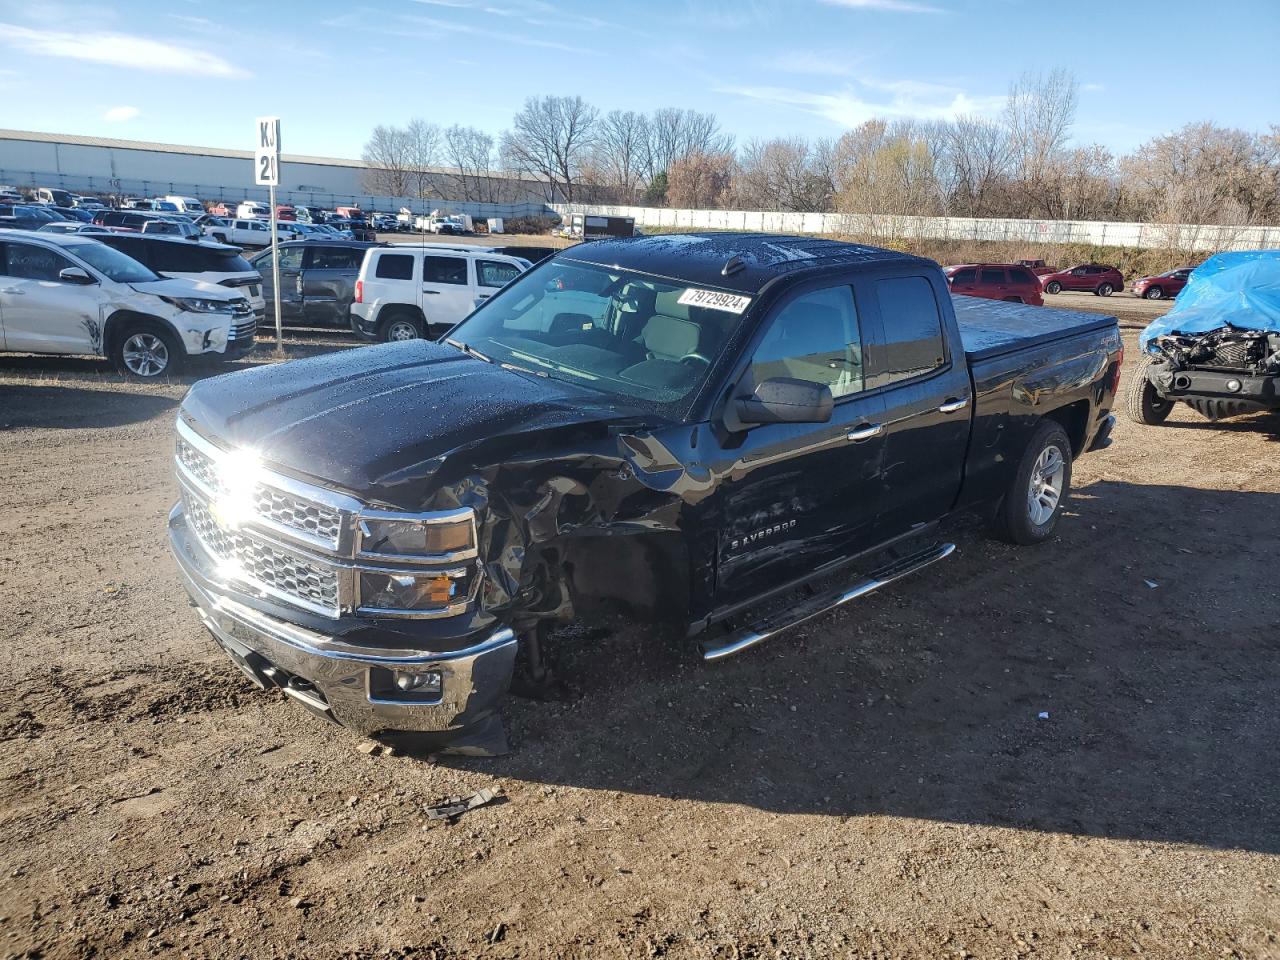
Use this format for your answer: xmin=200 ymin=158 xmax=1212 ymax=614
xmin=559 ymin=233 xmax=934 ymax=294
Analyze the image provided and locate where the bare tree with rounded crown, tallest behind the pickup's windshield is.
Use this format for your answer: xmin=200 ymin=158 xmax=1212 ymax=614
xmin=502 ymin=96 xmax=599 ymax=202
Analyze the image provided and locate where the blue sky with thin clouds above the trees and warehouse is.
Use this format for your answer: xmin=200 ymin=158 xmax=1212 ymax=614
xmin=0 ymin=0 xmax=1280 ymax=157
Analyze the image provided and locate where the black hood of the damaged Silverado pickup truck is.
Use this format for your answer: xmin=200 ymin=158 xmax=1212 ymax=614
xmin=182 ymin=340 xmax=641 ymax=509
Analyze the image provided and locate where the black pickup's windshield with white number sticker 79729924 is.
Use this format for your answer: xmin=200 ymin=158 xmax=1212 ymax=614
xmin=448 ymin=260 xmax=750 ymax=406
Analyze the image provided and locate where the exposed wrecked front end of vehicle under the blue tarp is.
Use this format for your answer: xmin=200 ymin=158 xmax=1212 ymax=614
xmin=1146 ymin=325 xmax=1280 ymax=420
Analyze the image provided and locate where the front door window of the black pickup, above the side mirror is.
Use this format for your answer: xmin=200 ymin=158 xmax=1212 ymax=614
xmin=751 ymin=287 xmax=863 ymax=399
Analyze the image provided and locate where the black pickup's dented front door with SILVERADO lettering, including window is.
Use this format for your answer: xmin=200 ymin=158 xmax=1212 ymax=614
xmin=717 ymin=285 xmax=884 ymax=608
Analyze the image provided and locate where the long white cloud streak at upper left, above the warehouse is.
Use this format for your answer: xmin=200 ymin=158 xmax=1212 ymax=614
xmin=0 ymin=23 xmax=248 ymax=77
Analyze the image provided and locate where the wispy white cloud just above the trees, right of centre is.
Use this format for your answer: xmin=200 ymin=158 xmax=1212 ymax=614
xmin=719 ymin=81 xmax=1005 ymax=127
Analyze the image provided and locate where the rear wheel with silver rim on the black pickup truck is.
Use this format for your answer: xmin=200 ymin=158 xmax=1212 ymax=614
xmin=991 ymin=420 xmax=1071 ymax=547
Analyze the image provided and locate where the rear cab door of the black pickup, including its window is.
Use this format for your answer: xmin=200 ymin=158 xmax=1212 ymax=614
xmin=855 ymin=273 xmax=973 ymax=540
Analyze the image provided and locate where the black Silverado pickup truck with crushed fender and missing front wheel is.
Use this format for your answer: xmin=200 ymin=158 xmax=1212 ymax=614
xmin=169 ymin=234 xmax=1123 ymax=754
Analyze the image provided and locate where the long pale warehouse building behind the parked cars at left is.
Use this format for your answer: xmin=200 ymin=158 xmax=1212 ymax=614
xmin=0 ymin=129 xmax=545 ymax=216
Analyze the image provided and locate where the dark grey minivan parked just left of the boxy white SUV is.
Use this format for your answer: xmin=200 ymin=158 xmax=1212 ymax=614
xmin=250 ymin=239 xmax=381 ymax=330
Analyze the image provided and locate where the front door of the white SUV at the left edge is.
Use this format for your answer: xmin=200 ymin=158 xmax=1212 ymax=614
xmin=0 ymin=241 xmax=102 ymax=353
